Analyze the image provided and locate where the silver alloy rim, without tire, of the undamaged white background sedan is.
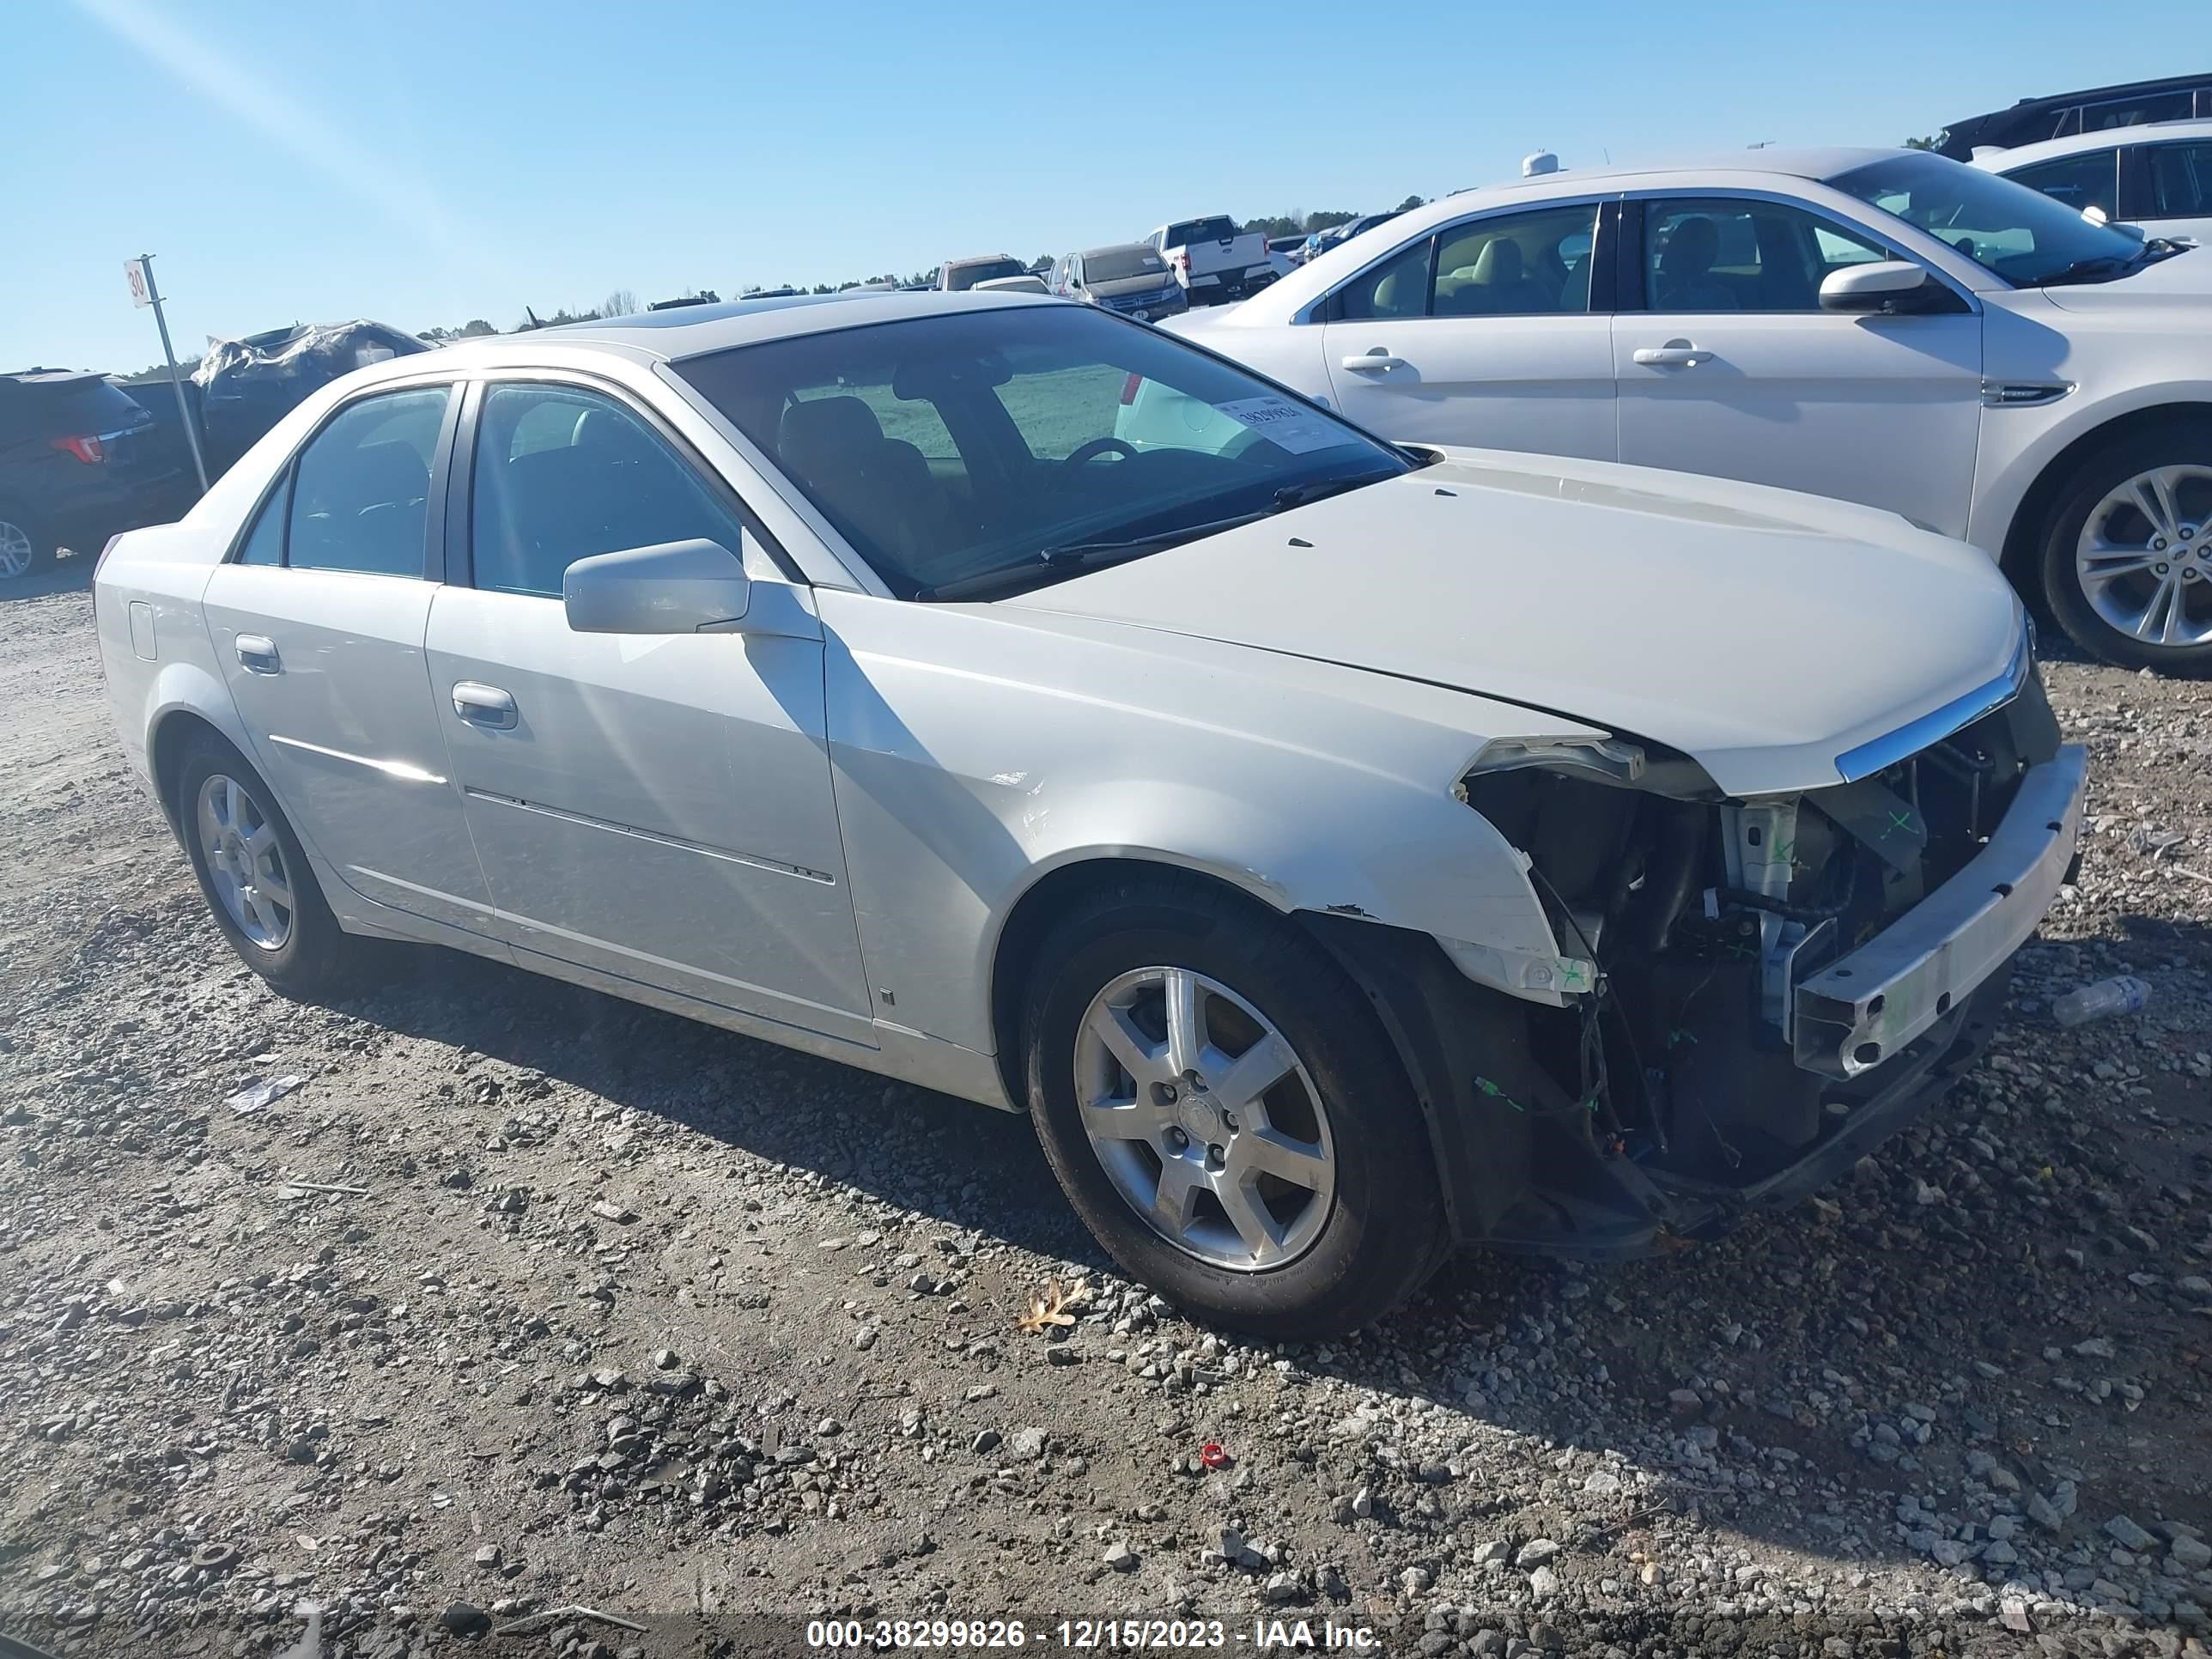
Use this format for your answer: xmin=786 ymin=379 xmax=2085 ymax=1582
xmin=2075 ymin=465 xmax=2212 ymax=646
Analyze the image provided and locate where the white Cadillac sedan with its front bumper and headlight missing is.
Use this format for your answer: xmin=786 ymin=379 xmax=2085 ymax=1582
xmin=95 ymin=295 xmax=2081 ymax=1334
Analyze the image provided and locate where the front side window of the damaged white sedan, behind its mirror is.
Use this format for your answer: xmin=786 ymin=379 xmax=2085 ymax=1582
xmin=469 ymin=383 xmax=744 ymax=599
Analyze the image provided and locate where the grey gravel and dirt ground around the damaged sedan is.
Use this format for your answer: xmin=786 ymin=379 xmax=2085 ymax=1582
xmin=0 ymin=560 xmax=2212 ymax=1659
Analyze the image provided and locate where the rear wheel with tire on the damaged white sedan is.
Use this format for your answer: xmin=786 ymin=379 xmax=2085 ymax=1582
xmin=173 ymin=730 xmax=374 ymax=1002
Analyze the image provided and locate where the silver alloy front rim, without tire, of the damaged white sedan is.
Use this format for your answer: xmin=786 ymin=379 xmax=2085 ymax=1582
xmin=1075 ymin=967 xmax=1336 ymax=1272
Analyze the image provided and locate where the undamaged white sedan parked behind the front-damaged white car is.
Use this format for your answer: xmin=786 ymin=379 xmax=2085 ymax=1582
xmin=1158 ymin=150 xmax=2212 ymax=672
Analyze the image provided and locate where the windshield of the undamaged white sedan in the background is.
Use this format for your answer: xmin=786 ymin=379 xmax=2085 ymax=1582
xmin=1829 ymin=153 xmax=2143 ymax=288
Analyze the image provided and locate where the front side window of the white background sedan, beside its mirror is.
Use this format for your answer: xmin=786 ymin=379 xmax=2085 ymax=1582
xmin=1644 ymin=197 xmax=1889 ymax=312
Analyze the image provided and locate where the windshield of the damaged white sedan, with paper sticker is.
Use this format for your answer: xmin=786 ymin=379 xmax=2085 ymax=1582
xmin=677 ymin=305 xmax=1409 ymax=598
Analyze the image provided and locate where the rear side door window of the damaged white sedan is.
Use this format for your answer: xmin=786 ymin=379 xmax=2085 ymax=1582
xmin=285 ymin=385 xmax=453 ymax=577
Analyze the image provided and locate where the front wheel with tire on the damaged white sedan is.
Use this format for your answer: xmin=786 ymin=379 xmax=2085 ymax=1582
xmin=1024 ymin=876 xmax=1449 ymax=1338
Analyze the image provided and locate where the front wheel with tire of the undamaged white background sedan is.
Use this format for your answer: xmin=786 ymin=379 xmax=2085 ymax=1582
xmin=2044 ymin=431 xmax=2212 ymax=675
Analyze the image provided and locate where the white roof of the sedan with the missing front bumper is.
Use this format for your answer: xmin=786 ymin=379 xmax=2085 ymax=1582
xmin=394 ymin=289 xmax=1046 ymax=372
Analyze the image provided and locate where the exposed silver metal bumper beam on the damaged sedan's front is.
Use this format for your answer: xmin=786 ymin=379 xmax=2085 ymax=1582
xmin=1792 ymin=744 xmax=2088 ymax=1078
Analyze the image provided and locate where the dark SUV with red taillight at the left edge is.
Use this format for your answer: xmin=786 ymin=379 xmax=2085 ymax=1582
xmin=0 ymin=369 xmax=192 ymax=584
